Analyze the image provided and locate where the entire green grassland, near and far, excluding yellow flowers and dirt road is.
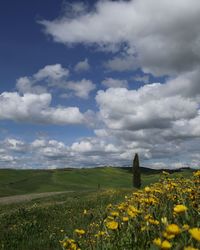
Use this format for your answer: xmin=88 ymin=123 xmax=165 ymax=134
xmin=0 ymin=167 xmax=195 ymax=250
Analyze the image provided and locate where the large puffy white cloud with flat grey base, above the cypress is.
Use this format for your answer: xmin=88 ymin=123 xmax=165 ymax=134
xmin=96 ymin=84 xmax=198 ymax=130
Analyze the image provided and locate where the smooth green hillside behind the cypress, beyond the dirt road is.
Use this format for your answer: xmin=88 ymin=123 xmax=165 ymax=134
xmin=0 ymin=167 xmax=191 ymax=197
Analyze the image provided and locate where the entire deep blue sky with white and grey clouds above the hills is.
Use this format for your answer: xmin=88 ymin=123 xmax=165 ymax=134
xmin=0 ymin=0 xmax=200 ymax=168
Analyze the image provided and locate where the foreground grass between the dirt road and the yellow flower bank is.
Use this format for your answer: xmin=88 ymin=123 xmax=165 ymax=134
xmin=0 ymin=189 xmax=131 ymax=250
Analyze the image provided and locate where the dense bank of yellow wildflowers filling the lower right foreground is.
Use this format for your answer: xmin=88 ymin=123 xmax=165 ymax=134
xmin=61 ymin=171 xmax=200 ymax=250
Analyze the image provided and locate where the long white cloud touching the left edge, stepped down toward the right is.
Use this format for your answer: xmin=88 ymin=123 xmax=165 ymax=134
xmin=0 ymin=92 xmax=84 ymax=125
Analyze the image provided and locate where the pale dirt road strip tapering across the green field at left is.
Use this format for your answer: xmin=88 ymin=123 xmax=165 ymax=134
xmin=0 ymin=191 xmax=73 ymax=205
